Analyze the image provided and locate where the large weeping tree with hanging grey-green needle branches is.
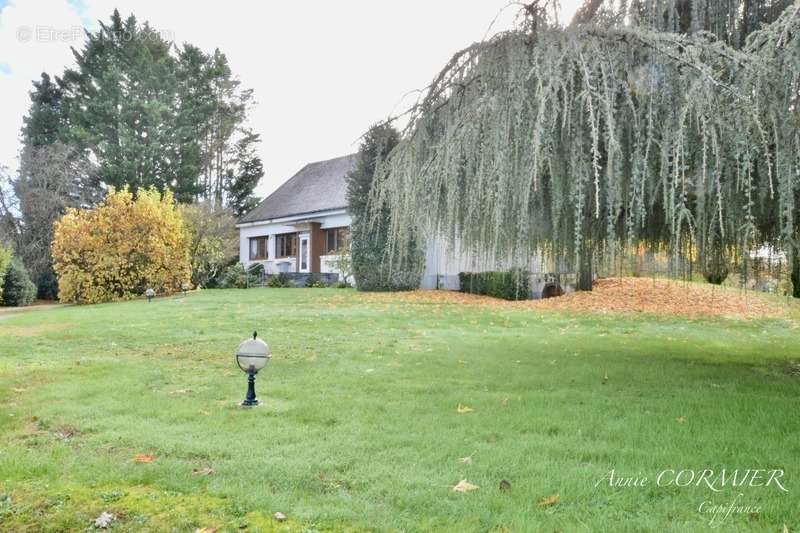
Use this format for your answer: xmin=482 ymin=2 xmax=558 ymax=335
xmin=370 ymin=0 xmax=800 ymax=296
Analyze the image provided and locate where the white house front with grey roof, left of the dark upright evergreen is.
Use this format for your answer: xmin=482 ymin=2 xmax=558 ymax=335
xmin=236 ymin=154 xmax=356 ymax=277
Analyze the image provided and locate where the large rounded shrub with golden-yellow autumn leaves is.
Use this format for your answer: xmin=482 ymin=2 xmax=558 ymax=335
xmin=52 ymin=188 xmax=191 ymax=303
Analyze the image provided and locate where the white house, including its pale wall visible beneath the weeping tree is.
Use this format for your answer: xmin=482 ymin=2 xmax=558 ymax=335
xmin=236 ymin=154 xmax=564 ymax=296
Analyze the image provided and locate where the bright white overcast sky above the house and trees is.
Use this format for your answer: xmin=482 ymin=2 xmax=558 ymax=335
xmin=0 ymin=0 xmax=580 ymax=195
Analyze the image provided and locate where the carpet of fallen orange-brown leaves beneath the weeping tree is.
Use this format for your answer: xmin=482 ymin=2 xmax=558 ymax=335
xmin=374 ymin=278 xmax=790 ymax=318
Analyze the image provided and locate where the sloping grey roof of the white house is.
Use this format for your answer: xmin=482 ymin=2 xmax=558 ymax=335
xmin=239 ymin=154 xmax=358 ymax=224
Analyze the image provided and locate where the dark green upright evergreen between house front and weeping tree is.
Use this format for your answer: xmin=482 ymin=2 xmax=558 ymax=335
xmin=345 ymin=124 xmax=421 ymax=291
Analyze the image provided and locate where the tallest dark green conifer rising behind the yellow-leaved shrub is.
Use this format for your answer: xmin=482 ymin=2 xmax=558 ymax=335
xmin=63 ymin=10 xmax=183 ymax=190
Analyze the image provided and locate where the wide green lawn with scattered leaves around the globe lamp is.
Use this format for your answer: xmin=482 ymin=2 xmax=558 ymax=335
xmin=0 ymin=289 xmax=800 ymax=532
